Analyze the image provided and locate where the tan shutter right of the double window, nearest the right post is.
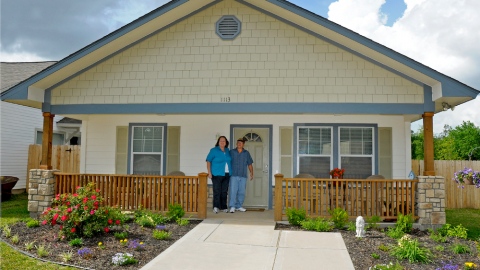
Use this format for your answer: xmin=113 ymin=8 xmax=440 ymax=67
xmin=378 ymin=127 xmax=394 ymax=179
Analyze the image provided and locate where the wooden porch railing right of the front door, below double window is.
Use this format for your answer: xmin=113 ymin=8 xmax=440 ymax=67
xmin=275 ymin=174 xmax=418 ymax=221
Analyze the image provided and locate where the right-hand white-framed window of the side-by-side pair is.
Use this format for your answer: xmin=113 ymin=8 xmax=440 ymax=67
xmin=338 ymin=127 xmax=375 ymax=179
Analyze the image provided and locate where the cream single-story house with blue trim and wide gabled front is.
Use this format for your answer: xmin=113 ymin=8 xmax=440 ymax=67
xmin=2 ymin=0 xmax=479 ymax=207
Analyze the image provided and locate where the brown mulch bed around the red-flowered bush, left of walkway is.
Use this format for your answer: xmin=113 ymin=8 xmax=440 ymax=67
xmin=4 ymin=220 xmax=201 ymax=270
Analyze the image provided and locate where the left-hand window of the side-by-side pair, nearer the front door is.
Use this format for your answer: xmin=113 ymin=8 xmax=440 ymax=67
xmin=297 ymin=127 xmax=333 ymax=178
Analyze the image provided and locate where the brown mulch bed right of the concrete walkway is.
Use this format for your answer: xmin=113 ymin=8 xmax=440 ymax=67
xmin=275 ymin=223 xmax=480 ymax=270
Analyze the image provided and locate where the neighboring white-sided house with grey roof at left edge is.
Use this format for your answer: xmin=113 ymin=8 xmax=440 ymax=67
xmin=0 ymin=61 xmax=81 ymax=189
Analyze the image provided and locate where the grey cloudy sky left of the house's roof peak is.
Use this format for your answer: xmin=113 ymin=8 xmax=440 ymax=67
xmin=1 ymin=0 xmax=168 ymax=61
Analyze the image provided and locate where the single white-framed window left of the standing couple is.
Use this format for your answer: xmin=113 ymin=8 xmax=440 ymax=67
xmin=130 ymin=126 xmax=164 ymax=175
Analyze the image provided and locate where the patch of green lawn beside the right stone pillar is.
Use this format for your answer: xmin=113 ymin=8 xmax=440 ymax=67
xmin=445 ymin=209 xmax=480 ymax=241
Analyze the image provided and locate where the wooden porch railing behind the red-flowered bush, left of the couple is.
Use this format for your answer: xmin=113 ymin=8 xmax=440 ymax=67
xmin=55 ymin=173 xmax=207 ymax=219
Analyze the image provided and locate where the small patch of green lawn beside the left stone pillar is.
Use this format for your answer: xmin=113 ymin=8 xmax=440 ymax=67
xmin=0 ymin=193 xmax=30 ymax=227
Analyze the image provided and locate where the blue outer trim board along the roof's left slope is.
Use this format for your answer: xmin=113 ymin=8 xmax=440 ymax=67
xmin=1 ymin=0 xmax=189 ymax=100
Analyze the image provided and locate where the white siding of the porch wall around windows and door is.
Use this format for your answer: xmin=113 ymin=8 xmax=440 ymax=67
xmin=82 ymin=114 xmax=410 ymax=179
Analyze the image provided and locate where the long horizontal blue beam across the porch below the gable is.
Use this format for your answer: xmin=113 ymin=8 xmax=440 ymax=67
xmin=51 ymin=102 xmax=425 ymax=115
